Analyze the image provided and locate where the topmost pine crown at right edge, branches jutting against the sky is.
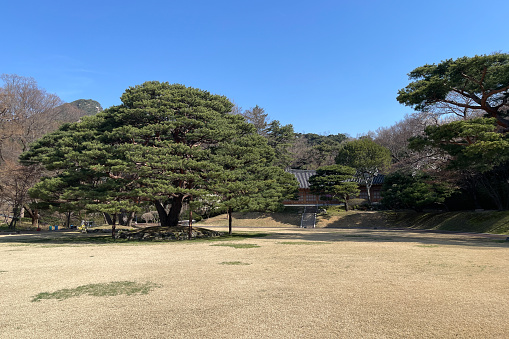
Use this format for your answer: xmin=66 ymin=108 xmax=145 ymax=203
xmin=397 ymin=53 xmax=509 ymax=131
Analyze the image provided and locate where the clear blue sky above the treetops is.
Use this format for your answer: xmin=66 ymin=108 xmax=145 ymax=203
xmin=0 ymin=0 xmax=509 ymax=137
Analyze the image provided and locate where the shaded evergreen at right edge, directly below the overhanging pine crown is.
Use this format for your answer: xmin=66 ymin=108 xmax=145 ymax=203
xmin=409 ymin=118 xmax=509 ymax=210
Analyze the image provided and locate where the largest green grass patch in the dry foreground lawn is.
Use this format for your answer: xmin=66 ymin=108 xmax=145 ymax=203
xmin=32 ymin=281 xmax=161 ymax=302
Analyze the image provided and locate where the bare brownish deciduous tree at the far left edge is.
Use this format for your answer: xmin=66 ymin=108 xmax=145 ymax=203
xmin=0 ymin=74 xmax=62 ymax=227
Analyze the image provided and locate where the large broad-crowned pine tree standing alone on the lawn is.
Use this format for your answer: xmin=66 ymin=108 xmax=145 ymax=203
xmin=23 ymin=82 xmax=296 ymax=226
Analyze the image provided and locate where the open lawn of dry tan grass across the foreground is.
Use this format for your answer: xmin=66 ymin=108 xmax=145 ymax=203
xmin=0 ymin=227 xmax=509 ymax=338
